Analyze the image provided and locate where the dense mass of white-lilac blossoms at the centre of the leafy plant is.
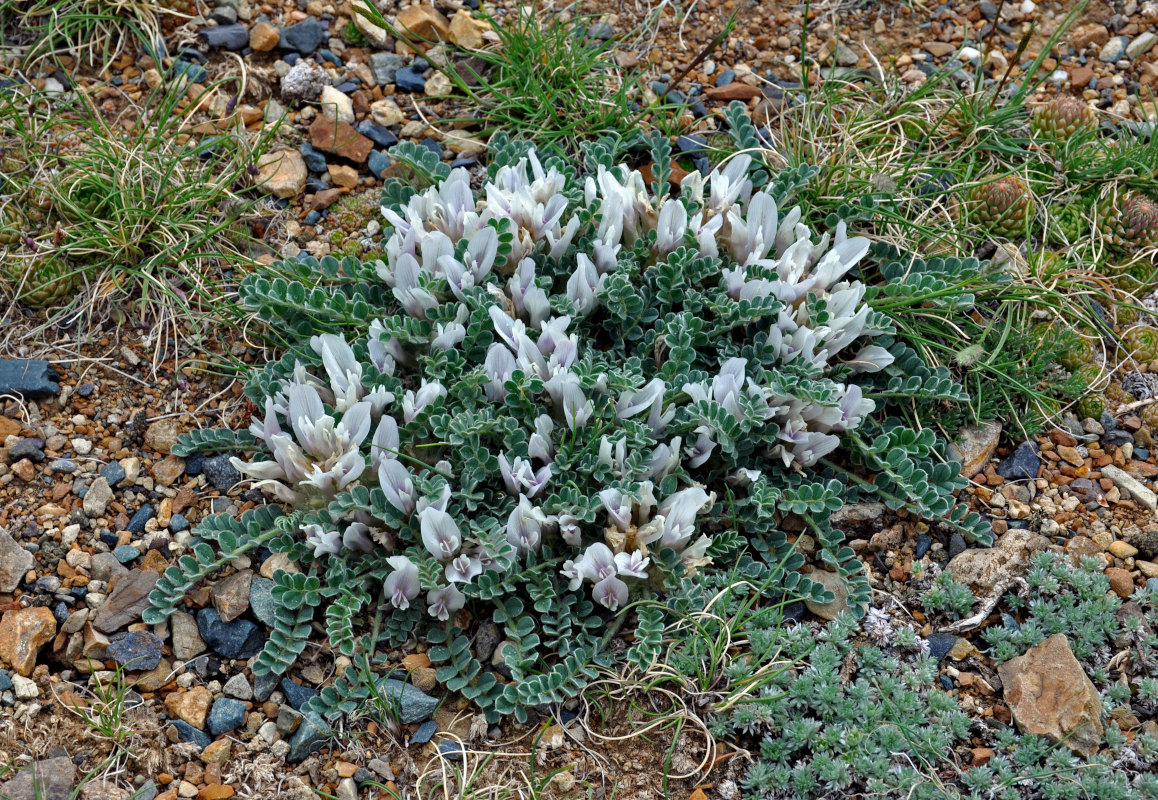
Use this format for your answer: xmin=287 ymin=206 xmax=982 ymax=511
xmin=235 ymin=144 xmax=893 ymax=619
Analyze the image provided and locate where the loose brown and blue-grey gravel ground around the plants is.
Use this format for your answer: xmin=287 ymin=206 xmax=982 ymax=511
xmin=0 ymin=0 xmax=1158 ymax=800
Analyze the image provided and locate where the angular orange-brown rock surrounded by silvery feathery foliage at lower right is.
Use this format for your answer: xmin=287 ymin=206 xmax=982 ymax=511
xmin=997 ymin=633 xmax=1105 ymax=758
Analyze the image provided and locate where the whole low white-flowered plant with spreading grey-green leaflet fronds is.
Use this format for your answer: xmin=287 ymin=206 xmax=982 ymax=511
xmin=154 ymin=120 xmax=985 ymax=715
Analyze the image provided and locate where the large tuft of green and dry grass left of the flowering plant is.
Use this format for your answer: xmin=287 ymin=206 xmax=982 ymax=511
xmin=0 ymin=85 xmax=275 ymax=349
